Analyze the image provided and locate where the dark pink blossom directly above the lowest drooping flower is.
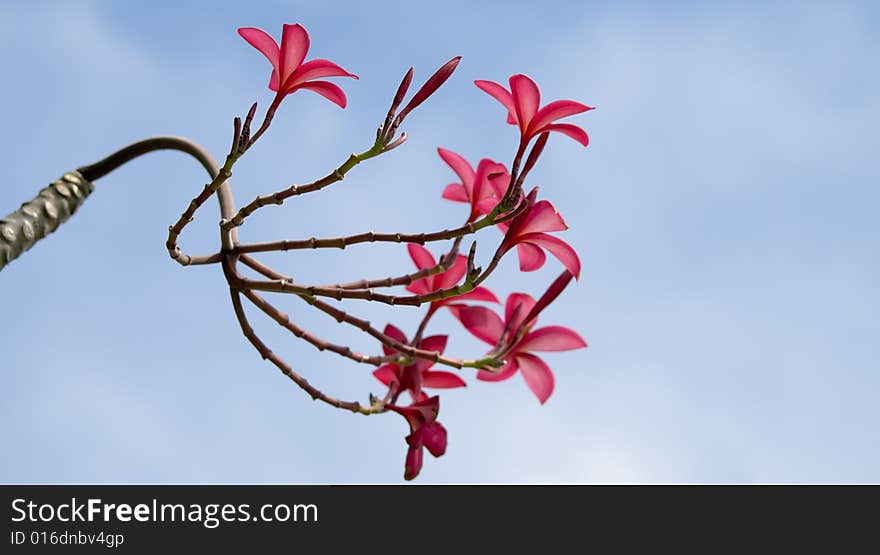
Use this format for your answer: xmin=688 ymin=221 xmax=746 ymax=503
xmin=373 ymin=324 xmax=466 ymax=401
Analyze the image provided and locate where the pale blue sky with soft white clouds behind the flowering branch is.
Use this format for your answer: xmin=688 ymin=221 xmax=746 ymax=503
xmin=0 ymin=2 xmax=880 ymax=483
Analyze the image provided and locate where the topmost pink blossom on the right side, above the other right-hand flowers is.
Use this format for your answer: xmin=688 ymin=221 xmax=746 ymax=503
xmin=474 ymin=74 xmax=593 ymax=146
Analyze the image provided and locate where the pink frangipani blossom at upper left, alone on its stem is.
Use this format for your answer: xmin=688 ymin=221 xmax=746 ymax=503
xmin=238 ymin=23 xmax=358 ymax=108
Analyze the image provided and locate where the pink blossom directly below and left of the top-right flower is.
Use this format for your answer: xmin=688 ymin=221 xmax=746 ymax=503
xmin=437 ymin=148 xmax=510 ymax=222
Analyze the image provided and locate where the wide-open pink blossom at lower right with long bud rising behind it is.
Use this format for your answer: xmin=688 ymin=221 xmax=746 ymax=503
xmin=449 ymin=271 xmax=587 ymax=404
